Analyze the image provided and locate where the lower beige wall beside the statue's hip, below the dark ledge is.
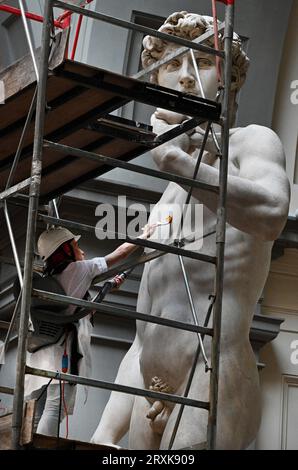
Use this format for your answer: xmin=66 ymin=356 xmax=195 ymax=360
xmin=256 ymin=249 xmax=298 ymax=449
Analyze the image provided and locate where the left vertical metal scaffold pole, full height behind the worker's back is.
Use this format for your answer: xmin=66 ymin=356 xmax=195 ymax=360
xmin=12 ymin=0 xmax=52 ymax=449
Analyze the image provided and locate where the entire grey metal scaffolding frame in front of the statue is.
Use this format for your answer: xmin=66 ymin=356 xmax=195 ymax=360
xmin=0 ymin=0 xmax=234 ymax=449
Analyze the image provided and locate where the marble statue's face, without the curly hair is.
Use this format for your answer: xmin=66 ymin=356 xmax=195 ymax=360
xmin=158 ymin=46 xmax=218 ymax=100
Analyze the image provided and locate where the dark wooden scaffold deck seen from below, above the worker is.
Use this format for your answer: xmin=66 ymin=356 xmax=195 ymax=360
xmin=0 ymin=34 xmax=220 ymax=202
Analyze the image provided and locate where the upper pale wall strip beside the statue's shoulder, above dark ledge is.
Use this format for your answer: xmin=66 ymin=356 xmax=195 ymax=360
xmin=273 ymin=1 xmax=298 ymax=215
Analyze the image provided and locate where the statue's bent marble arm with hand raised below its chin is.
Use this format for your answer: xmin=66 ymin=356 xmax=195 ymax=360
xmin=152 ymin=112 xmax=289 ymax=240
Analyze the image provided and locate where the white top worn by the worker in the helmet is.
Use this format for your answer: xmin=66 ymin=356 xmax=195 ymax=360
xmin=25 ymin=258 xmax=108 ymax=413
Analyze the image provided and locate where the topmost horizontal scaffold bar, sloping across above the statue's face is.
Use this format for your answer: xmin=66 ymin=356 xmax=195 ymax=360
xmin=53 ymin=0 xmax=225 ymax=57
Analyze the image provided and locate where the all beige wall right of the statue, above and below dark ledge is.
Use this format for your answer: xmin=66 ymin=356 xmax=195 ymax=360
xmin=256 ymin=1 xmax=298 ymax=449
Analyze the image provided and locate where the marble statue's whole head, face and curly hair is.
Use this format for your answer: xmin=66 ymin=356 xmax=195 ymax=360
xmin=142 ymin=11 xmax=249 ymax=119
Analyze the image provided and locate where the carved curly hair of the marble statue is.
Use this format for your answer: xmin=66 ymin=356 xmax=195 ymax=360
xmin=142 ymin=11 xmax=249 ymax=92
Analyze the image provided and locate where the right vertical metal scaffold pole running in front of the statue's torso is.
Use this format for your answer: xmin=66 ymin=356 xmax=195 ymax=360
xmin=207 ymin=0 xmax=234 ymax=450
